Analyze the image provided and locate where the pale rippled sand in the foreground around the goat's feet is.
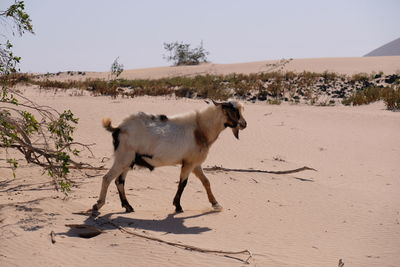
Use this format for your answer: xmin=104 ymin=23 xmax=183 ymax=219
xmin=0 ymin=57 xmax=400 ymax=267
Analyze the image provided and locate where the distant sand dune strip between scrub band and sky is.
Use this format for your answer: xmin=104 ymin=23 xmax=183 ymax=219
xmin=46 ymin=56 xmax=400 ymax=80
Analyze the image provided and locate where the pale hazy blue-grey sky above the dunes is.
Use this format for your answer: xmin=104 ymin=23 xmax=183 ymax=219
xmin=0 ymin=0 xmax=400 ymax=72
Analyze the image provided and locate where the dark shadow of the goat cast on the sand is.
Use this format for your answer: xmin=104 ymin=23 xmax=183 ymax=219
xmin=85 ymin=211 xmax=216 ymax=234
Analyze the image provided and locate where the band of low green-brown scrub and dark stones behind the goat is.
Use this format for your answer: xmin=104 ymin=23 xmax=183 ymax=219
xmin=6 ymin=68 xmax=400 ymax=110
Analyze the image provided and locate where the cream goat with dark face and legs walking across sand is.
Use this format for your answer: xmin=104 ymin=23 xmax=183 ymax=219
xmin=92 ymin=101 xmax=247 ymax=216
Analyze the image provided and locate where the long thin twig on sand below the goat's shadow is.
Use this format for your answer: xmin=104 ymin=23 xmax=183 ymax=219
xmin=97 ymin=218 xmax=252 ymax=264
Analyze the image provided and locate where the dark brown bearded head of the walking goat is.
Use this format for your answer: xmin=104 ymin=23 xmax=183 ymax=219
xmin=213 ymin=100 xmax=247 ymax=139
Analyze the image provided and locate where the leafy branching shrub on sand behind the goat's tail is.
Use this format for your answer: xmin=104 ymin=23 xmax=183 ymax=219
xmin=0 ymin=89 xmax=104 ymax=190
